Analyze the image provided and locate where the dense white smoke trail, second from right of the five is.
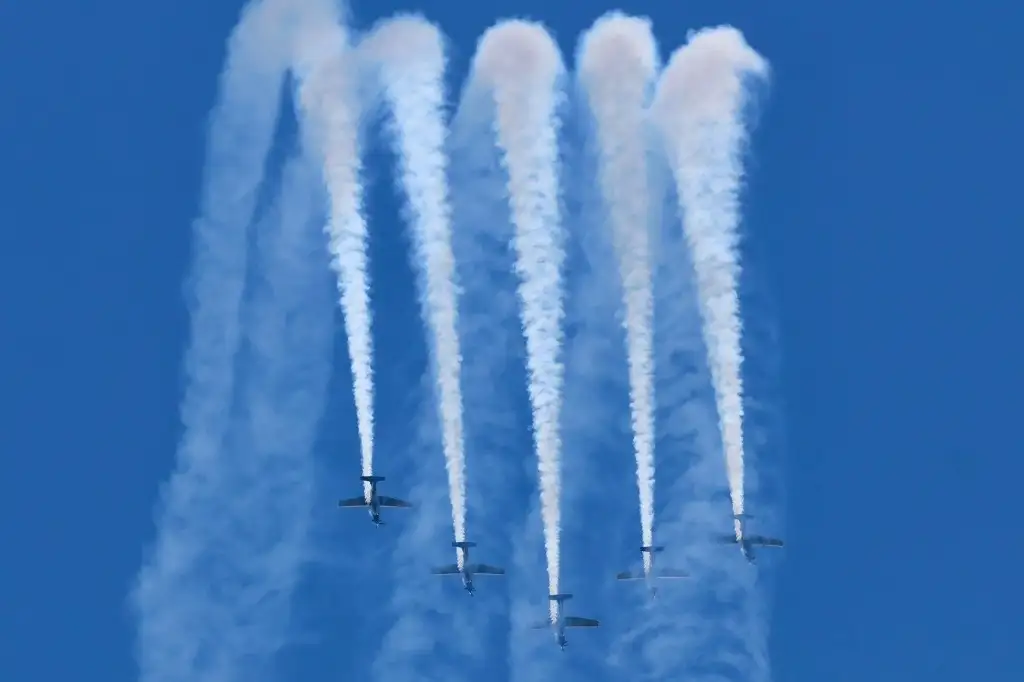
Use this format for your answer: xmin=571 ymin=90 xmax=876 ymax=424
xmin=578 ymin=12 xmax=658 ymax=572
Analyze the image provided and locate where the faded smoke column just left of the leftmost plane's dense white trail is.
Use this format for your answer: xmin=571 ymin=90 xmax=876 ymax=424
xmin=218 ymin=146 xmax=334 ymax=679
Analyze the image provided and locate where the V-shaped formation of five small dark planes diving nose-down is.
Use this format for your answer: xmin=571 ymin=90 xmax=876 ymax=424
xmin=338 ymin=476 xmax=783 ymax=651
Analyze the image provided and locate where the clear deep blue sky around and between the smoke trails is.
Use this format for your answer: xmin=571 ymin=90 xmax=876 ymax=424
xmin=0 ymin=0 xmax=1024 ymax=681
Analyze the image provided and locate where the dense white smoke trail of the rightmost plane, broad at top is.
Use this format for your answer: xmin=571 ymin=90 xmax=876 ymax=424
xmin=652 ymin=27 xmax=768 ymax=524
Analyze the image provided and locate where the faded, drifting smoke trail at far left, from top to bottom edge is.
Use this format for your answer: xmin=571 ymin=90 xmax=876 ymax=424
xmin=131 ymin=2 xmax=296 ymax=682
